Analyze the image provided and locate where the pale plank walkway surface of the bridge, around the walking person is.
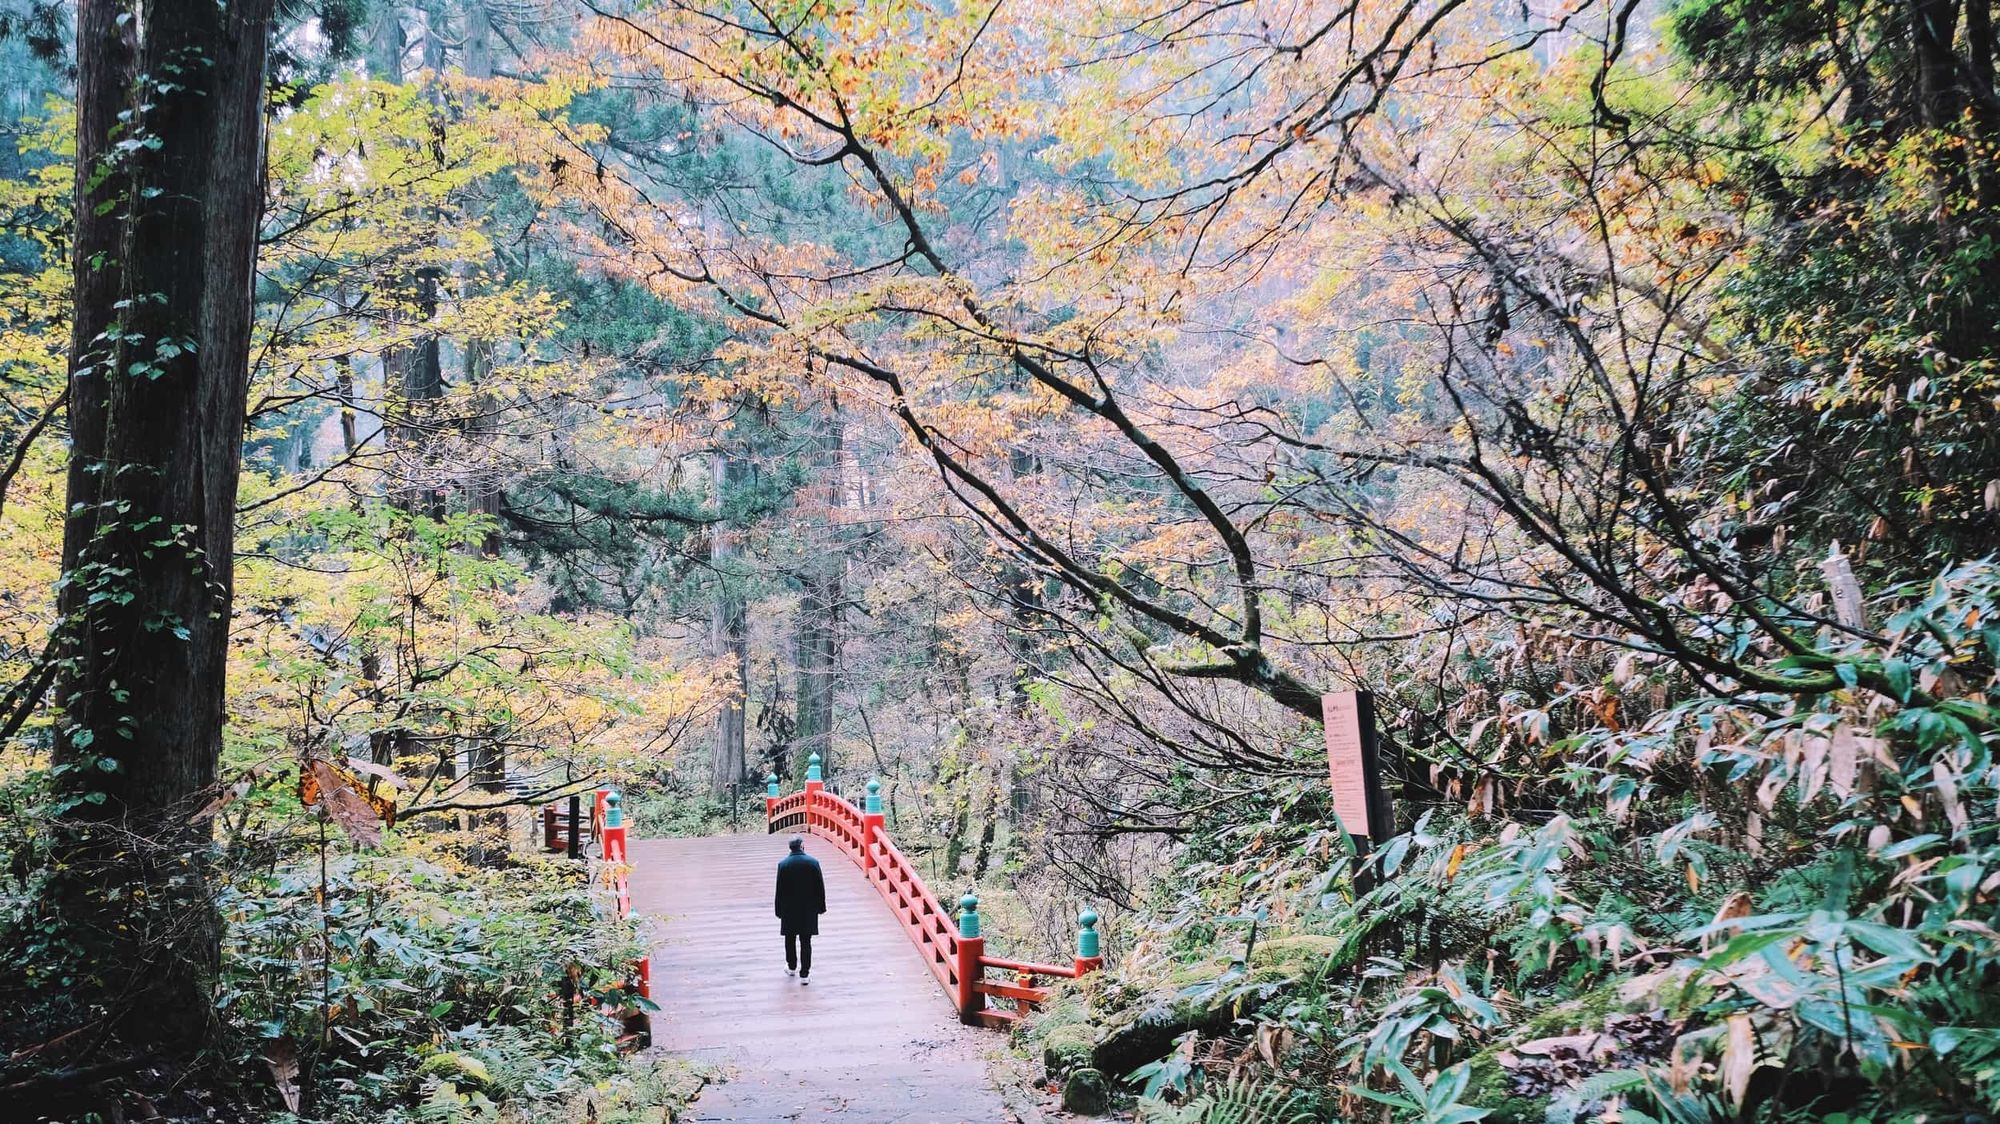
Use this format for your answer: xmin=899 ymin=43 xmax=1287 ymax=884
xmin=630 ymin=834 xmax=1008 ymax=1124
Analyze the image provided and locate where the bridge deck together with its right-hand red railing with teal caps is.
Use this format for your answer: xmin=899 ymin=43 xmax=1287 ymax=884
xmin=616 ymin=752 xmax=1100 ymax=1124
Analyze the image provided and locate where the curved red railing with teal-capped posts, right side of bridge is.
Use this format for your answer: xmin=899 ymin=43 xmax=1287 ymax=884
xmin=764 ymin=754 xmax=1104 ymax=1026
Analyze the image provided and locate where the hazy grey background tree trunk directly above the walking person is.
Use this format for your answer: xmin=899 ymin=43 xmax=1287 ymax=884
xmin=796 ymin=398 xmax=848 ymax=774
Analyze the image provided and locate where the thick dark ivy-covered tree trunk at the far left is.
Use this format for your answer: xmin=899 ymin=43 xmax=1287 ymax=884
xmin=46 ymin=0 xmax=272 ymax=1056
